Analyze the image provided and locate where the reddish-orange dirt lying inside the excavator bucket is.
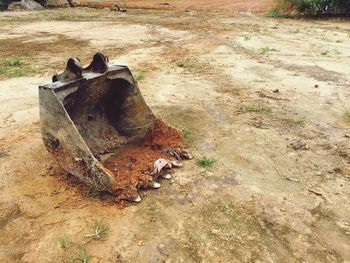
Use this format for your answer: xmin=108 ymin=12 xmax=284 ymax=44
xmin=104 ymin=119 xmax=183 ymax=198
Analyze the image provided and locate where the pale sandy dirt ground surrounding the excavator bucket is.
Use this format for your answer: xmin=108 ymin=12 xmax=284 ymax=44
xmin=0 ymin=8 xmax=350 ymax=263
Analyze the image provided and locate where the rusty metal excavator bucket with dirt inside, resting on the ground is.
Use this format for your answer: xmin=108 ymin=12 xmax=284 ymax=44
xmin=39 ymin=53 xmax=190 ymax=201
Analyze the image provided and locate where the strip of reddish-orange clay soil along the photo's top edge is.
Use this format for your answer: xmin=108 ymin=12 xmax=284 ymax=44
xmin=75 ymin=0 xmax=274 ymax=12
